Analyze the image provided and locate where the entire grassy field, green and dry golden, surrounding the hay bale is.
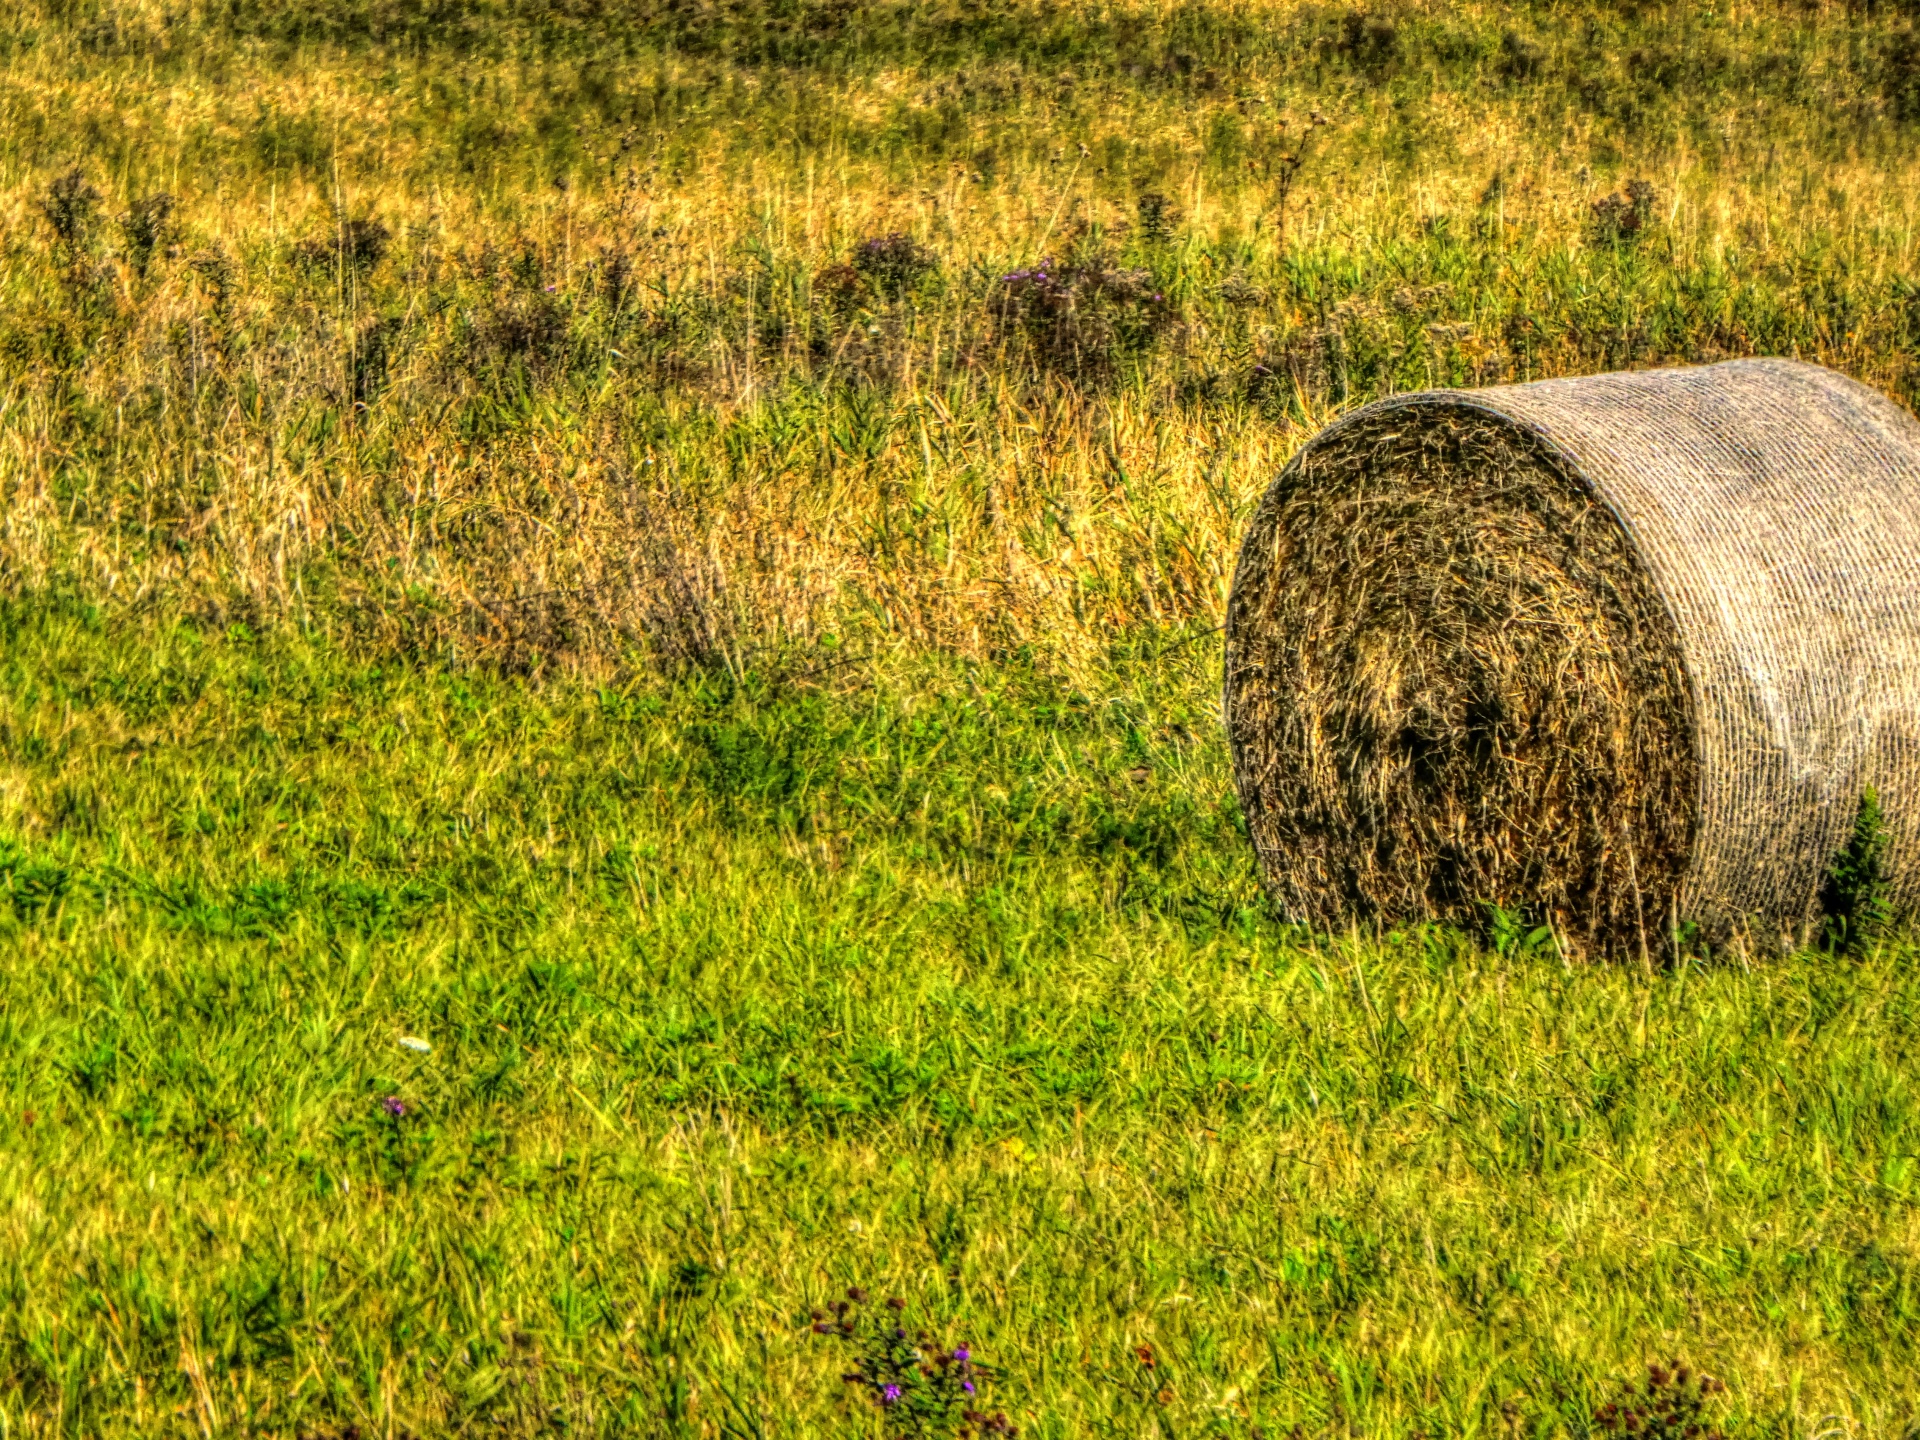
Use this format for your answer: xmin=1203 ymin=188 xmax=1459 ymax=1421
xmin=11 ymin=0 xmax=1920 ymax=1440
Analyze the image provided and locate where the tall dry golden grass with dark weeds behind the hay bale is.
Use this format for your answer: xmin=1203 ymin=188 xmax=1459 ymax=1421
xmin=0 ymin=4 xmax=1920 ymax=672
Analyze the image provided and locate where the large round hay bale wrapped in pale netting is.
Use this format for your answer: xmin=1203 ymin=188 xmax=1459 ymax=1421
xmin=1225 ymin=361 xmax=1920 ymax=952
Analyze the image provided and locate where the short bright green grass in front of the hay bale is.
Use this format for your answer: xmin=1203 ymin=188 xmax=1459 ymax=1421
xmin=0 ymin=605 xmax=1920 ymax=1436
